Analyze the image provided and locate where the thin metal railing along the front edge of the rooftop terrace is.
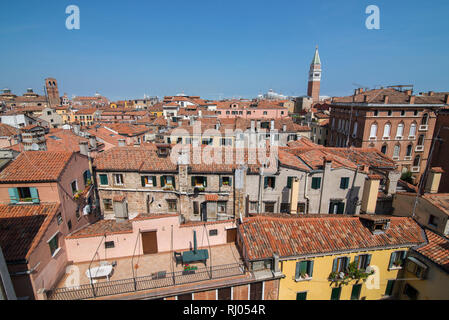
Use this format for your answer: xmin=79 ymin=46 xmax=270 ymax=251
xmin=47 ymin=263 xmax=245 ymax=300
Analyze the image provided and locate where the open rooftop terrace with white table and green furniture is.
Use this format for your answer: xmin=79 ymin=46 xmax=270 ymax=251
xmin=47 ymin=243 xmax=245 ymax=300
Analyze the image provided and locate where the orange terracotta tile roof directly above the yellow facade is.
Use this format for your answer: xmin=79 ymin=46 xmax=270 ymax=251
xmin=239 ymin=216 xmax=425 ymax=260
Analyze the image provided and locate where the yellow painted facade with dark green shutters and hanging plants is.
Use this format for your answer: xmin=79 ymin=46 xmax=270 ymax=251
xmin=279 ymin=247 xmax=408 ymax=300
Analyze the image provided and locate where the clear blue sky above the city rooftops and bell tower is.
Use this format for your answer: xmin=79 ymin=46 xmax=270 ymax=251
xmin=0 ymin=0 xmax=449 ymax=99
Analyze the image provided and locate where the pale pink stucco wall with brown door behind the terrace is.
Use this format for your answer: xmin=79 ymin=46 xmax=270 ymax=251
xmin=65 ymin=216 xmax=235 ymax=263
